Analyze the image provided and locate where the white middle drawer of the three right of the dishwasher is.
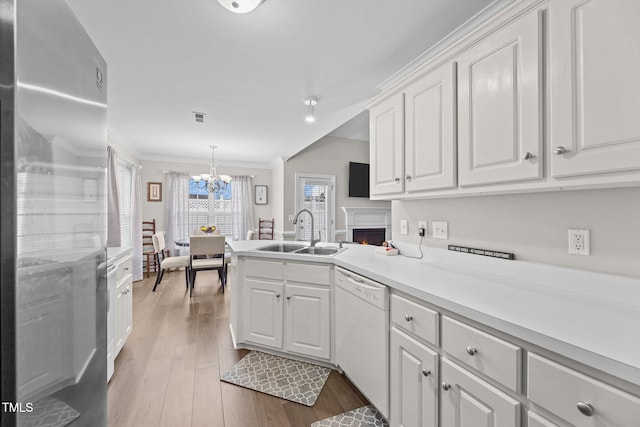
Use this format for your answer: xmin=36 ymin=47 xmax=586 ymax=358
xmin=442 ymin=316 xmax=522 ymax=392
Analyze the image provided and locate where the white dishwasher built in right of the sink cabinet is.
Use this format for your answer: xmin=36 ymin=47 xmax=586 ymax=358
xmin=335 ymin=267 xmax=389 ymax=418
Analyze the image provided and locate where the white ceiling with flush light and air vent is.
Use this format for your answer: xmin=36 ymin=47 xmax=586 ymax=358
xmin=69 ymin=0 xmax=504 ymax=166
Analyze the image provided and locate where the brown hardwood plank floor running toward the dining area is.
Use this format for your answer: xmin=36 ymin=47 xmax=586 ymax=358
xmin=108 ymin=271 xmax=368 ymax=427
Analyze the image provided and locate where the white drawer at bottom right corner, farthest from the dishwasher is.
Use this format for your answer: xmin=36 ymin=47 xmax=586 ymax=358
xmin=527 ymin=353 xmax=640 ymax=427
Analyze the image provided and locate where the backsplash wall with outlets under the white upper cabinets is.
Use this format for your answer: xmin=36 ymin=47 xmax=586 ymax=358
xmin=392 ymin=187 xmax=640 ymax=278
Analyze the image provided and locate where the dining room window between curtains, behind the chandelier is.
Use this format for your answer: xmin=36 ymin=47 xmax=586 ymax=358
xmin=189 ymin=179 xmax=233 ymax=236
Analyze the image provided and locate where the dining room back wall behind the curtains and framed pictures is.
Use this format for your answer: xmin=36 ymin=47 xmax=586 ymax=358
xmin=141 ymin=160 xmax=273 ymax=230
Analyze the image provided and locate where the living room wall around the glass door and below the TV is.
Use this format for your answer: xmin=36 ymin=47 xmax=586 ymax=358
xmin=283 ymin=136 xmax=390 ymax=240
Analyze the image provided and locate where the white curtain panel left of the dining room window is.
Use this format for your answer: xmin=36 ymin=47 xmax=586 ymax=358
xmin=164 ymin=172 xmax=189 ymax=256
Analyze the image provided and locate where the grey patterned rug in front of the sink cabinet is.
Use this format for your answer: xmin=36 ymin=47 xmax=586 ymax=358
xmin=220 ymin=351 xmax=331 ymax=406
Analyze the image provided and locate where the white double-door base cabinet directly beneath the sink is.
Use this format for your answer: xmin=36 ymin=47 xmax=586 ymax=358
xmin=239 ymin=260 xmax=331 ymax=359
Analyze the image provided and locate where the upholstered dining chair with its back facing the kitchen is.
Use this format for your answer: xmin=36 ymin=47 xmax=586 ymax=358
xmin=189 ymin=235 xmax=227 ymax=295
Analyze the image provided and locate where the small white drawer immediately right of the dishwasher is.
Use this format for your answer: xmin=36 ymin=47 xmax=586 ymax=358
xmin=391 ymin=295 xmax=439 ymax=346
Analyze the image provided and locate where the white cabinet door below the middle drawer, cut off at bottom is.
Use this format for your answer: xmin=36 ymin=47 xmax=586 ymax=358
xmin=440 ymin=358 xmax=520 ymax=427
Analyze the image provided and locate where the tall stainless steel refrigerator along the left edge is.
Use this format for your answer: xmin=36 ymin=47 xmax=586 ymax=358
xmin=0 ymin=0 xmax=107 ymax=426
